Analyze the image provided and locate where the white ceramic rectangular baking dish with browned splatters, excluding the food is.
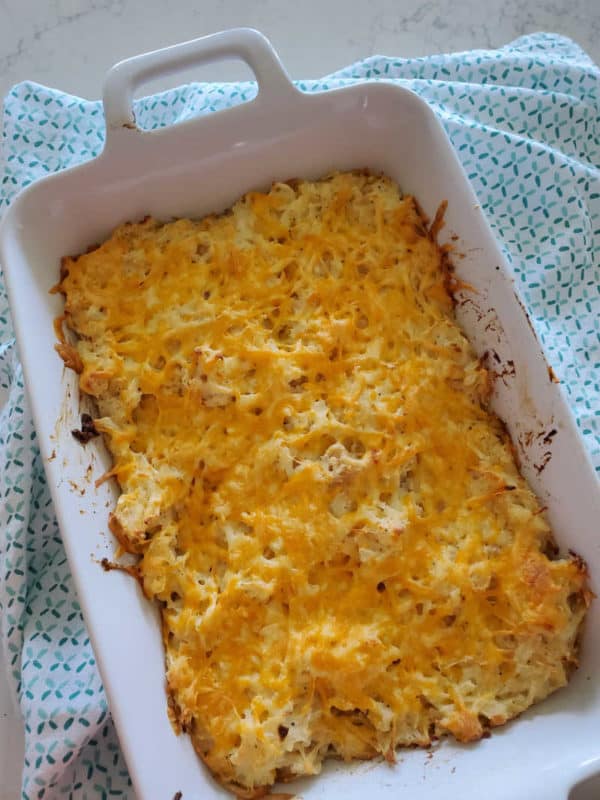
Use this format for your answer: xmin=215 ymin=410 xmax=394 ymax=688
xmin=0 ymin=29 xmax=600 ymax=800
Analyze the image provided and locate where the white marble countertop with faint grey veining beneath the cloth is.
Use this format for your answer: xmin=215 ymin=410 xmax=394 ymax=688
xmin=0 ymin=0 xmax=600 ymax=800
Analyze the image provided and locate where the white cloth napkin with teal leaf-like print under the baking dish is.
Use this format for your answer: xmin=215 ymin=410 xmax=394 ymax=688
xmin=0 ymin=34 xmax=600 ymax=800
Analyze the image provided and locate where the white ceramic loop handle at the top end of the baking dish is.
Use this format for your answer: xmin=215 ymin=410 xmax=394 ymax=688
xmin=103 ymin=28 xmax=299 ymax=134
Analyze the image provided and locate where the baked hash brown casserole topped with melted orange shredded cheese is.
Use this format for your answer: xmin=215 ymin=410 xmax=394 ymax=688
xmin=58 ymin=172 xmax=589 ymax=797
